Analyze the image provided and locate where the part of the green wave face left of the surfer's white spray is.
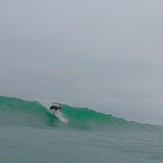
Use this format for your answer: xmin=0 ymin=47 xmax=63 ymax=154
xmin=0 ymin=97 xmax=58 ymax=127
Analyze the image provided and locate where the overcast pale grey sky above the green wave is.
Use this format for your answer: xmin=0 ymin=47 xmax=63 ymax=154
xmin=0 ymin=0 xmax=163 ymax=125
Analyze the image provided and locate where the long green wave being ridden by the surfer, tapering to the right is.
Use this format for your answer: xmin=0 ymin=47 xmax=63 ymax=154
xmin=0 ymin=96 xmax=162 ymax=130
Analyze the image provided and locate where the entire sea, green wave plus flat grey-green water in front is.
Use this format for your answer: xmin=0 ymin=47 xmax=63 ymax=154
xmin=0 ymin=96 xmax=163 ymax=163
